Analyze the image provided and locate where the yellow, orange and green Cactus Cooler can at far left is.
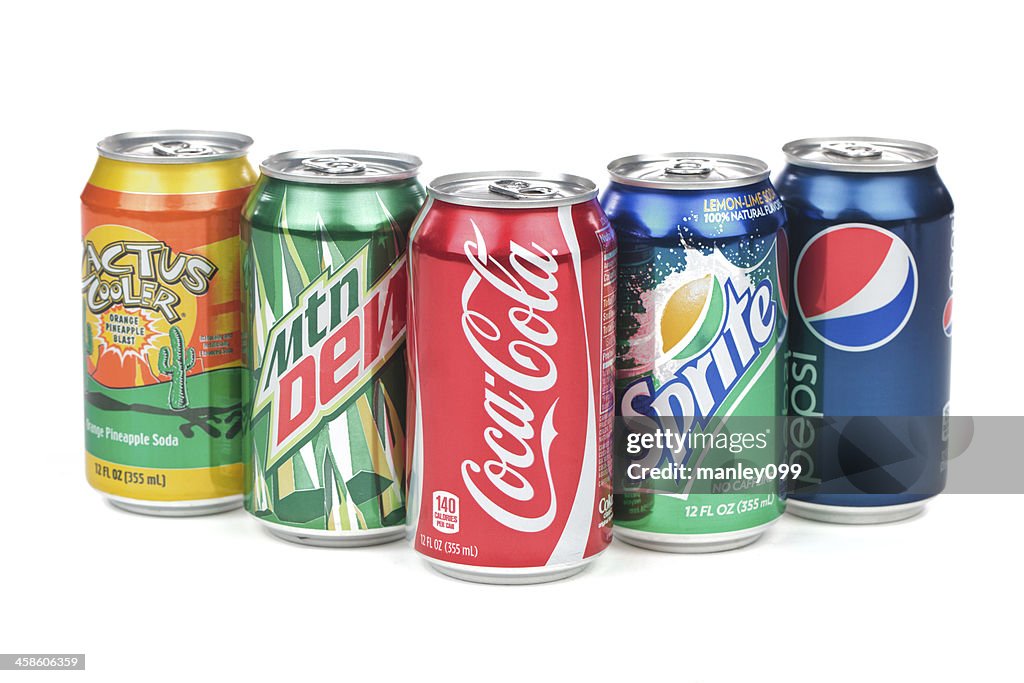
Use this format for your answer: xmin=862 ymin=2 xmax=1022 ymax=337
xmin=82 ymin=130 xmax=255 ymax=516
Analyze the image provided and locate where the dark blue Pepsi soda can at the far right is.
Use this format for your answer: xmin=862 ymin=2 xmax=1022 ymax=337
xmin=778 ymin=137 xmax=953 ymax=523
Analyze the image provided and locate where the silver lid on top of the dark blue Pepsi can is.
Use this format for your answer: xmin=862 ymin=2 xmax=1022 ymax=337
xmin=782 ymin=137 xmax=939 ymax=173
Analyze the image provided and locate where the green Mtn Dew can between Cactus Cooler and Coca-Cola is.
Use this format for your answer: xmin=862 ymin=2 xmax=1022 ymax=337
xmin=242 ymin=150 xmax=425 ymax=546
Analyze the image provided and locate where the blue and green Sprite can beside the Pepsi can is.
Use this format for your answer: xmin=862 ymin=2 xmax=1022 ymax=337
xmin=602 ymin=153 xmax=788 ymax=552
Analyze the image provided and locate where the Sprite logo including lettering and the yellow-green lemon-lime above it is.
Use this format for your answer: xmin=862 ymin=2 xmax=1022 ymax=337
xmin=620 ymin=240 xmax=785 ymax=467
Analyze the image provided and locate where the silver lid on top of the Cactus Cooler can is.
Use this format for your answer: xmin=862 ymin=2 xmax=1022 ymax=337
xmin=96 ymin=130 xmax=253 ymax=164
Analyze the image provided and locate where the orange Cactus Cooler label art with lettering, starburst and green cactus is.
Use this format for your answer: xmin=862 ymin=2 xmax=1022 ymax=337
xmin=82 ymin=225 xmax=235 ymax=403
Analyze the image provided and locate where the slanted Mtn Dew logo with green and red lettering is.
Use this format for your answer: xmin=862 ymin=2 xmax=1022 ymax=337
xmin=253 ymin=249 xmax=408 ymax=467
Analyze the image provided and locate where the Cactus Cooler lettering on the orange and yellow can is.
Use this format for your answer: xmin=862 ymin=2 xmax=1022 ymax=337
xmin=82 ymin=240 xmax=217 ymax=324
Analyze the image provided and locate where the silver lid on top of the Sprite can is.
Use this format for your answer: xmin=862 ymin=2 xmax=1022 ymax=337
xmin=608 ymin=152 xmax=768 ymax=189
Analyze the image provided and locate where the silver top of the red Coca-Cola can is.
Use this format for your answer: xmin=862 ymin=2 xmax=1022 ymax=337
xmin=427 ymin=171 xmax=597 ymax=209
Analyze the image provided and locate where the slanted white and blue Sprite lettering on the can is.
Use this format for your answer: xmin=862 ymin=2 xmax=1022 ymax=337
xmin=621 ymin=279 xmax=776 ymax=462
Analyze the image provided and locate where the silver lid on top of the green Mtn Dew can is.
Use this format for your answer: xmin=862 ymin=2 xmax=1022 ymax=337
xmin=259 ymin=150 xmax=423 ymax=185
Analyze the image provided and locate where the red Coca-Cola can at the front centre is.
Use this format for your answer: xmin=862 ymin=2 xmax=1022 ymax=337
xmin=409 ymin=171 xmax=615 ymax=584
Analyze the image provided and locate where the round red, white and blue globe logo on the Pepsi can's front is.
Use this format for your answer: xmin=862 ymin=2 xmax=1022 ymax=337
xmin=794 ymin=223 xmax=918 ymax=352
